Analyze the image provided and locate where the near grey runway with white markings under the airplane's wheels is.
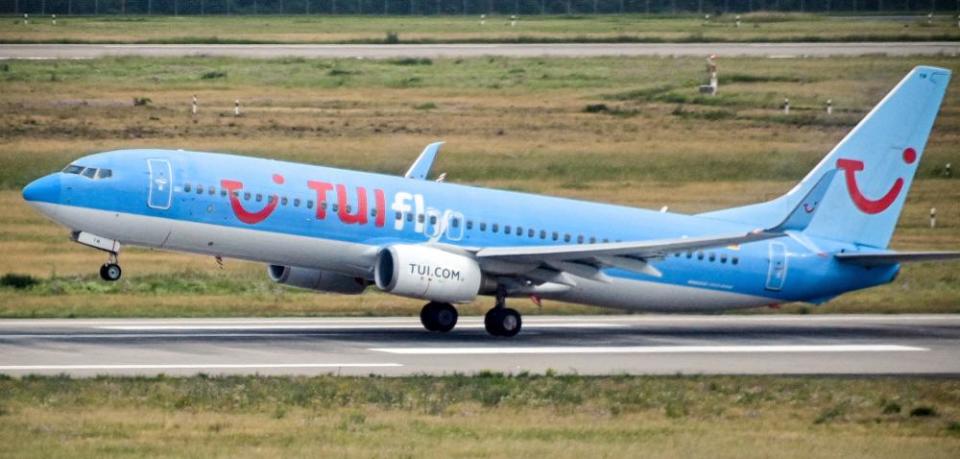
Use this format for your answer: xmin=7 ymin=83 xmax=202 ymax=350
xmin=0 ymin=315 xmax=960 ymax=376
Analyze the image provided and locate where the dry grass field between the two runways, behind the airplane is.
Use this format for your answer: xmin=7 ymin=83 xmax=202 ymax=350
xmin=0 ymin=57 xmax=960 ymax=317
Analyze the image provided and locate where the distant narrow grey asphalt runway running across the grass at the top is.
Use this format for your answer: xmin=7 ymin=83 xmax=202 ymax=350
xmin=0 ymin=42 xmax=960 ymax=59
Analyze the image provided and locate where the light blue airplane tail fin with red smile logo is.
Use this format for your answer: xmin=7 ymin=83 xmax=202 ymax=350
xmin=701 ymin=66 xmax=950 ymax=248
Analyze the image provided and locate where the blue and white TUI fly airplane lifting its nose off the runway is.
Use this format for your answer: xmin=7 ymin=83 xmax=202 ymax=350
xmin=23 ymin=66 xmax=960 ymax=337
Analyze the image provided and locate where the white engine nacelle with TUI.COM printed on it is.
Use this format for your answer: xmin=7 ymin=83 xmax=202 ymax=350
xmin=374 ymin=244 xmax=482 ymax=303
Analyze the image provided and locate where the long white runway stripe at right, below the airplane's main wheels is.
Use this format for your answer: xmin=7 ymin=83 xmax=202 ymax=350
xmin=370 ymin=344 xmax=930 ymax=355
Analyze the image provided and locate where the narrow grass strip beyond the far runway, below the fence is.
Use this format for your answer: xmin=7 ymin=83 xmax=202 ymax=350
xmin=0 ymin=13 xmax=960 ymax=43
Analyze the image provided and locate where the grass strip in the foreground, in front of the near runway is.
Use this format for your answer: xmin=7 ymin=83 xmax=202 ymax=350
xmin=0 ymin=374 xmax=960 ymax=458
